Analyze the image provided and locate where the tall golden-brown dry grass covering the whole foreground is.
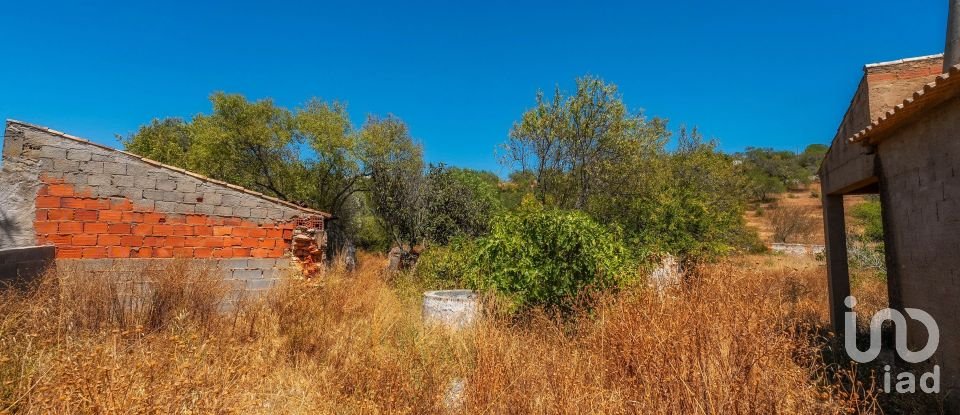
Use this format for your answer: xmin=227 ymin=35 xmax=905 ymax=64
xmin=0 ymin=256 xmax=876 ymax=414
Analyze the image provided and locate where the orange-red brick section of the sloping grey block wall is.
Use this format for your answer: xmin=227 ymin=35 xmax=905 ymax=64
xmin=34 ymin=178 xmax=295 ymax=259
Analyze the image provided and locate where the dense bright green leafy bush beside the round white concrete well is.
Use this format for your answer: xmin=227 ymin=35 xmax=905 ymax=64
xmin=469 ymin=209 xmax=636 ymax=311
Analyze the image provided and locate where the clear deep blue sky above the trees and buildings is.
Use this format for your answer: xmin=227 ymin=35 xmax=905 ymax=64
xmin=0 ymin=0 xmax=947 ymax=174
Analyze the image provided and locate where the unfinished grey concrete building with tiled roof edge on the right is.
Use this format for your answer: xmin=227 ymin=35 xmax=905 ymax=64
xmin=820 ymin=8 xmax=960 ymax=413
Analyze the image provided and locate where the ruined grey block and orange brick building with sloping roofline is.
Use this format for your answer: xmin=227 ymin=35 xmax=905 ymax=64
xmin=0 ymin=120 xmax=330 ymax=290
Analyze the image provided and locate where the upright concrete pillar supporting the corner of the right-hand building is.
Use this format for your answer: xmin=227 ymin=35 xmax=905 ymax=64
xmin=823 ymin=195 xmax=850 ymax=333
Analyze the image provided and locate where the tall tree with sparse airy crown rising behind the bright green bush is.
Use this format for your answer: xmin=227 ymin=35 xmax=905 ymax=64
xmin=504 ymin=76 xmax=667 ymax=209
